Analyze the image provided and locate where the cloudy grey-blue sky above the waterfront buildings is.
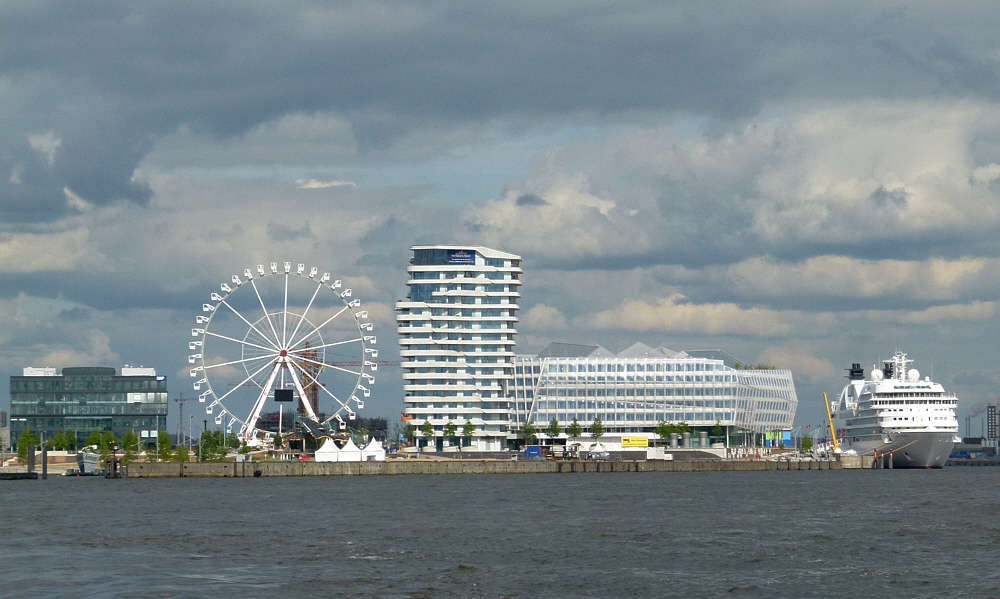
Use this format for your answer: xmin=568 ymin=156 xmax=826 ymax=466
xmin=0 ymin=0 xmax=1000 ymax=434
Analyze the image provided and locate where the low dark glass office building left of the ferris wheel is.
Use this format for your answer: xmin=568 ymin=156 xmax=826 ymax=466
xmin=10 ymin=366 xmax=167 ymax=445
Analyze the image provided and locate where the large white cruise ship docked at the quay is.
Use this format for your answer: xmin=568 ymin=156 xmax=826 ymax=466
xmin=832 ymin=351 xmax=959 ymax=468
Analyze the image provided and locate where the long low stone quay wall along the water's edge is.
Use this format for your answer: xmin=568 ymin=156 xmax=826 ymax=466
xmin=128 ymin=460 xmax=844 ymax=478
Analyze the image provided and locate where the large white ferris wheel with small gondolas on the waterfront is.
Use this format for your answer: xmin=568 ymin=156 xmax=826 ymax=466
xmin=188 ymin=262 xmax=378 ymax=443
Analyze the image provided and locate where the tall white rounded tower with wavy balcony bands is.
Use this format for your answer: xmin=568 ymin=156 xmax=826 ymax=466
xmin=396 ymin=245 xmax=522 ymax=451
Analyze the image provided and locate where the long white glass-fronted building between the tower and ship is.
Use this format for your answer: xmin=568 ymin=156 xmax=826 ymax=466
xmin=511 ymin=343 xmax=798 ymax=446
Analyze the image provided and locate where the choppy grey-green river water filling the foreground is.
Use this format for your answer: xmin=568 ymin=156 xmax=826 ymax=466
xmin=0 ymin=468 xmax=1000 ymax=599
